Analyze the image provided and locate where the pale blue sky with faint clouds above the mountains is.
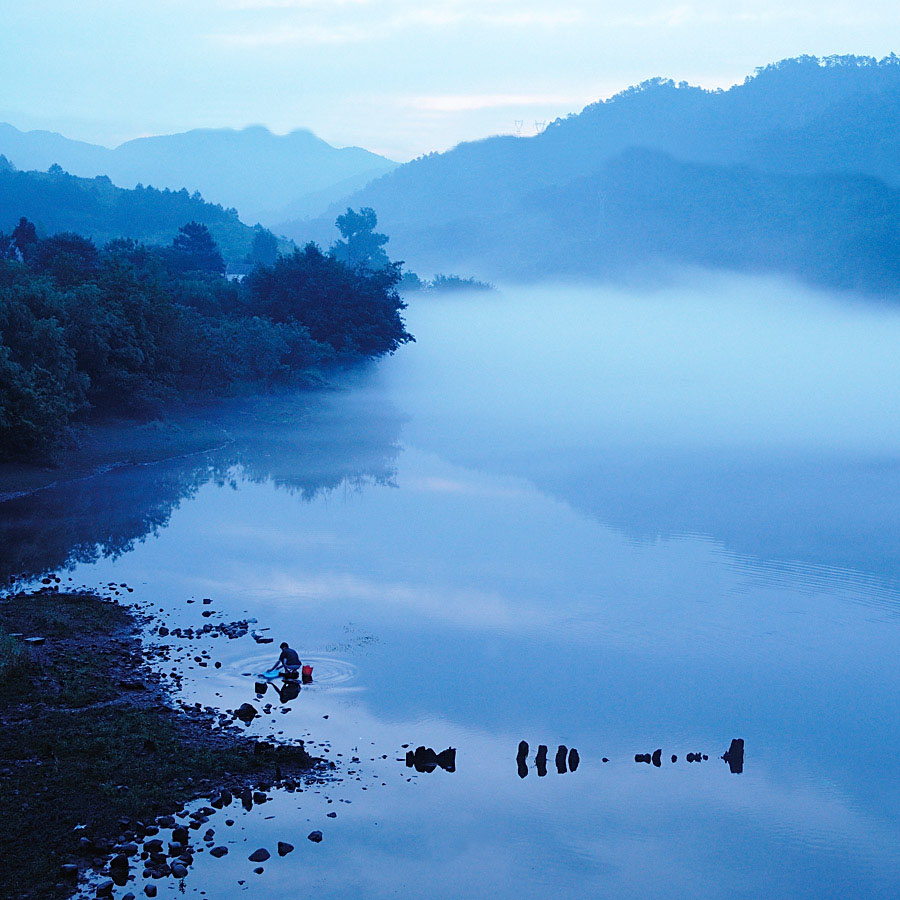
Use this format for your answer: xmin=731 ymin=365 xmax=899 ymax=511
xmin=0 ymin=0 xmax=900 ymax=161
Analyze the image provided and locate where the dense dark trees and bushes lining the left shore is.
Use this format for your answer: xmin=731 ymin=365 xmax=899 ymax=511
xmin=0 ymin=210 xmax=412 ymax=459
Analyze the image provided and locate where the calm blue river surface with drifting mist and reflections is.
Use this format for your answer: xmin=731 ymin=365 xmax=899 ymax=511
xmin=7 ymin=275 xmax=900 ymax=900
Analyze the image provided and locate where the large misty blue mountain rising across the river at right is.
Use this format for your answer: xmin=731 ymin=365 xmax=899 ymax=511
xmin=287 ymin=56 xmax=900 ymax=290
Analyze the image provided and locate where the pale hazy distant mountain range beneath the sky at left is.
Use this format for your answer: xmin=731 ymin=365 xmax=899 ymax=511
xmin=0 ymin=124 xmax=396 ymax=225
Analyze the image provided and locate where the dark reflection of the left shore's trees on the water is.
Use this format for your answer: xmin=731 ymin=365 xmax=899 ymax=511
xmin=0 ymin=384 xmax=402 ymax=583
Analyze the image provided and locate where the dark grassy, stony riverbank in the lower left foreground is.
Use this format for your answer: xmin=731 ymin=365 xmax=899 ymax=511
xmin=0 ymin=583 xmax=324 ymax=900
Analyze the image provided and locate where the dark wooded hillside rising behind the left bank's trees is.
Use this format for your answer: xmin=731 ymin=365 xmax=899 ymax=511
xmin=0 ymin=156 xmax=268 ymax=263
